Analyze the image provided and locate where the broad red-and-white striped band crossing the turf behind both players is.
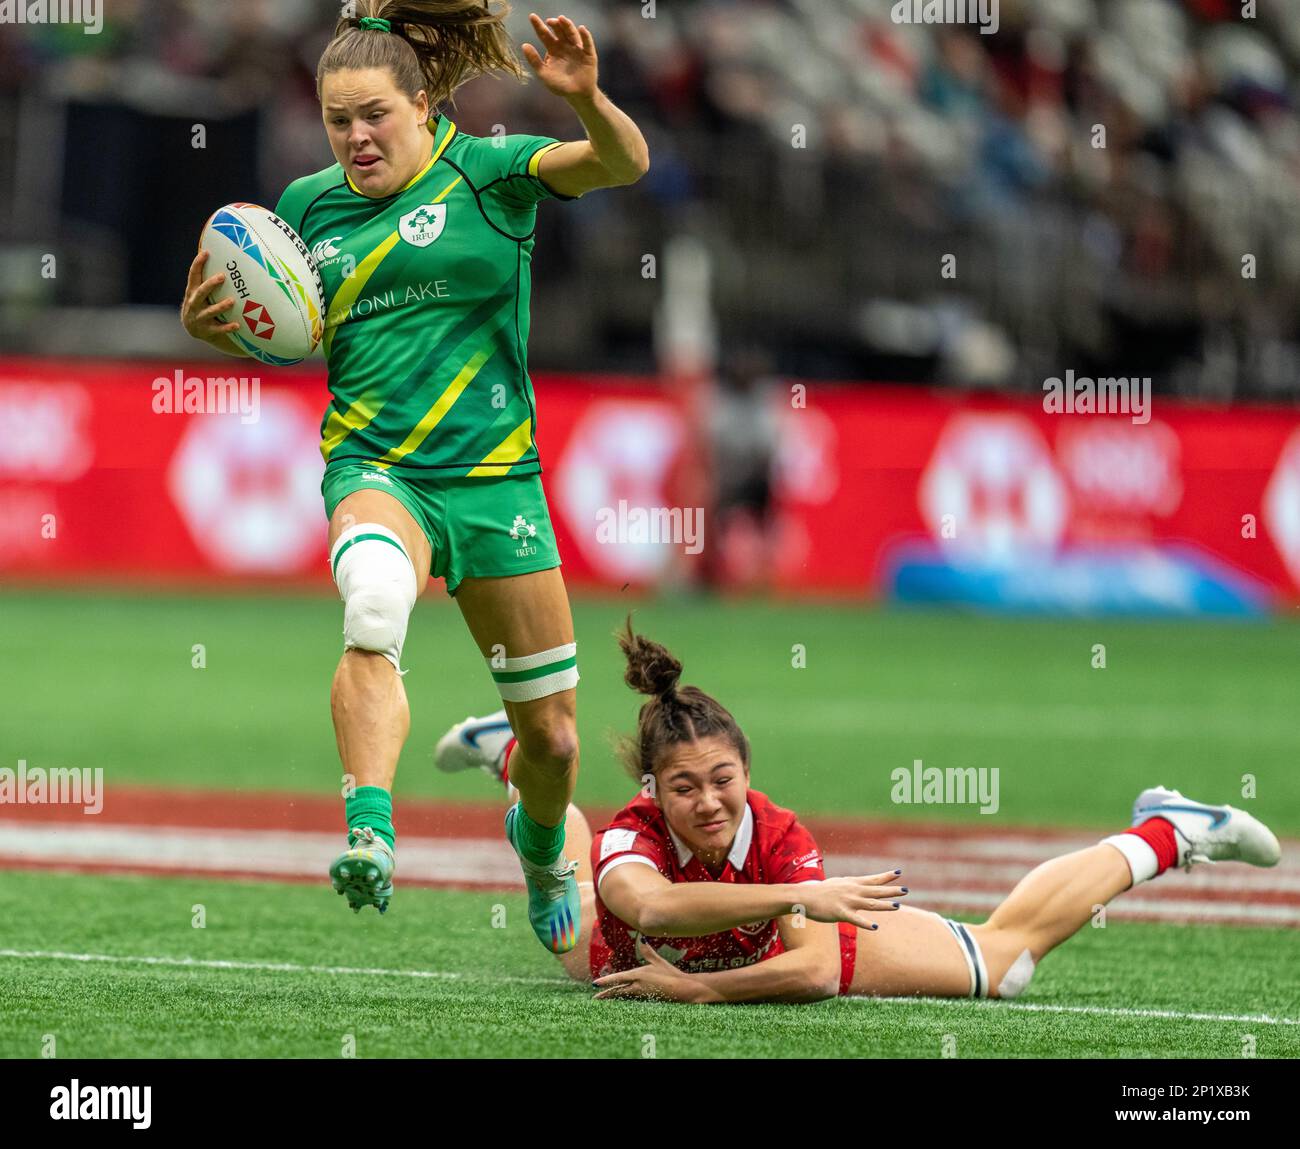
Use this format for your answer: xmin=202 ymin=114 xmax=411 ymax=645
xmin=0 ymin=786 xmax=1300 ymax=927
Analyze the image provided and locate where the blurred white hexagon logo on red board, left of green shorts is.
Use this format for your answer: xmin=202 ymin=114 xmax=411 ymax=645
xmin=166 ymin=391 xmax=324 ymax=575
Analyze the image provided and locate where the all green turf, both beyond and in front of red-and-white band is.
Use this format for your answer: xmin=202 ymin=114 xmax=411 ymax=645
xmin=0 ymin=591 xmax=1300 ymax=1057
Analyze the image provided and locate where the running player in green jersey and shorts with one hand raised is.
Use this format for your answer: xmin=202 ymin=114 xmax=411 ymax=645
xmin=182 ymin=0 xmax=650 ymax=953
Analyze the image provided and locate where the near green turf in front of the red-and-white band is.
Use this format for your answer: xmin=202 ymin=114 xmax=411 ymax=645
xmin=0 ymin=873 xmax=1300 ymax=1058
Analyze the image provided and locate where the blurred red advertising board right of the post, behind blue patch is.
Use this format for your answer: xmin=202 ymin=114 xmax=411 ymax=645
xmin=759 ymin=383 xmax=1300 ymax=597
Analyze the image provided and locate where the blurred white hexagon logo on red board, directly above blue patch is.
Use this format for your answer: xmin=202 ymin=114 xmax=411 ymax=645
xmin=919 ymin=413 xmax=1070 ymax=563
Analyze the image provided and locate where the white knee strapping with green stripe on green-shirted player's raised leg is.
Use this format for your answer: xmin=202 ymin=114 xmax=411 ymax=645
xmin=329 ymin=523 xmax=416 ymax=675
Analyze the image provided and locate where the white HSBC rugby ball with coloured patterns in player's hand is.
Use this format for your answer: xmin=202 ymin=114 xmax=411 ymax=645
xmin=199 ymin=203 xmax=325 ymax=367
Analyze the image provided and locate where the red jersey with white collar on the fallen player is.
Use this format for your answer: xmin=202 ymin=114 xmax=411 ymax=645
xmin=592 ymin=790 xmax=852 ymax=977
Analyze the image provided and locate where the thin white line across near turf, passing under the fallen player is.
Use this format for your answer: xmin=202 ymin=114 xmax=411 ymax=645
xmin=0 ymin=949 xmax=1300 ymax=1026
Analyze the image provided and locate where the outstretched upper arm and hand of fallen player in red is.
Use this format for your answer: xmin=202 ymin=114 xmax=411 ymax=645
xmin=601 ymin=866 xmax=904 ymax=937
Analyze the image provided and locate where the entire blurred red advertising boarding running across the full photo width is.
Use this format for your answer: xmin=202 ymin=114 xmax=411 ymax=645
xmin=0 ymin=360 xmax=1300 ymax=602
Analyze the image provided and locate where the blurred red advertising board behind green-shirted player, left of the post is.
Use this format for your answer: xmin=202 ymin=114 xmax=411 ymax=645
xmin=0 ymin=360 xmax=683 ymax=586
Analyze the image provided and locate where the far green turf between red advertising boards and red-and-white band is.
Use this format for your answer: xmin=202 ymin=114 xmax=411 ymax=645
xmin=0 ymin=589 xmax=1300 ymax=836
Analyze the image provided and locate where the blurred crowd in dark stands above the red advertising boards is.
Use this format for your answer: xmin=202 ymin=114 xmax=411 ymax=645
xmin=0 ymin=0 xmax=1300 ymax=399
